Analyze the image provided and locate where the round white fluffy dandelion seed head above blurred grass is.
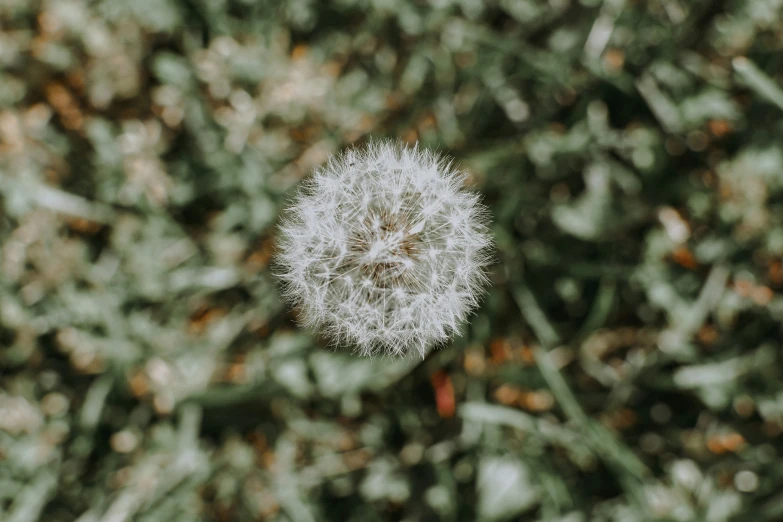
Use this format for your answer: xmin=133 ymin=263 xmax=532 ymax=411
xmin=276 ymin=142 xmax=492 ymax=357
